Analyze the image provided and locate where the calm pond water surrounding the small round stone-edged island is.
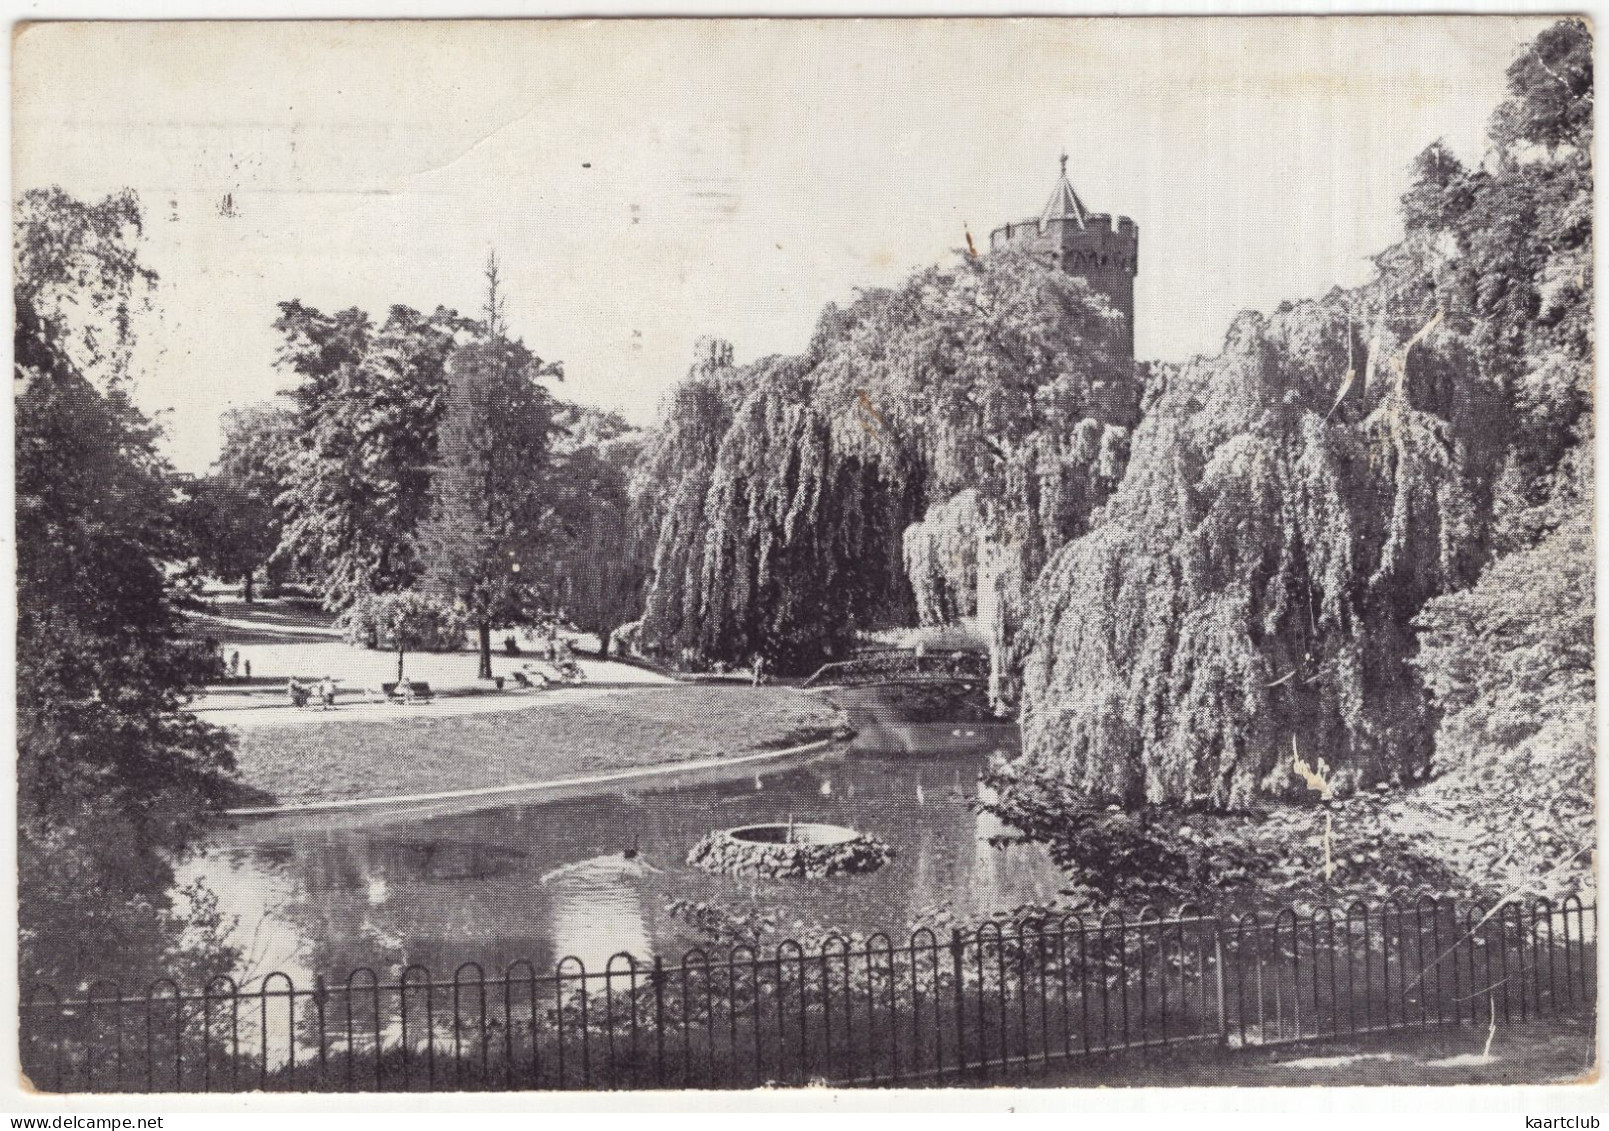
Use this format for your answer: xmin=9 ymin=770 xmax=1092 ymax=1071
xmin=182 ymin=704 xmax=1062 ymax=985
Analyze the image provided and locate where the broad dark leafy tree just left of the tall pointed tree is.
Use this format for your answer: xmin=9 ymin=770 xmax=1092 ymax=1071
xmin=275 ymin=302 xmax=476 ymax=608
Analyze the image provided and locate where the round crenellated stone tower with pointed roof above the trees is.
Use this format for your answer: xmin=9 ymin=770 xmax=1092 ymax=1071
xmin=990 ymin=153 xmax=1139 ymax=360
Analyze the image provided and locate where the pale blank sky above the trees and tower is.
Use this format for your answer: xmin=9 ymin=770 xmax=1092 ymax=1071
xmin=14 ymin=16 xmax=1548 ymax=470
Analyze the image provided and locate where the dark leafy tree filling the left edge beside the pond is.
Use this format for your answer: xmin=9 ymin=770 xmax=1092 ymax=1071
xmin=13 ymin=190 xmax=235 ymax=985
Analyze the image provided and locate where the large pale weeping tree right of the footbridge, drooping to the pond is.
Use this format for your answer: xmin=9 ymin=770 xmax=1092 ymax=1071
xmin=1022 ymin=293 xmax=1488 ymax=806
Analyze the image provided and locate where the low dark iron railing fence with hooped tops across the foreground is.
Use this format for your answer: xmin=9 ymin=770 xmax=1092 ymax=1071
xmin=21 ymin=898 xmax=1598 ymax=1092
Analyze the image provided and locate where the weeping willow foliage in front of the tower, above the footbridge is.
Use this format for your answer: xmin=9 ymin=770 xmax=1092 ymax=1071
xmin=637 ymin=253 xmax=1139 ymax=671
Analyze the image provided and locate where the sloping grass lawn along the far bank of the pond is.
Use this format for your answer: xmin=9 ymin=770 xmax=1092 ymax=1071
xmin=237 ymin=685 xmax=846 ymax=803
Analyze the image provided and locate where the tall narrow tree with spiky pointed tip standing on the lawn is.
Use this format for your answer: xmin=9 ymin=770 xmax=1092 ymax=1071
xmin=420 ymin=256 xmax=563 ymax=679
